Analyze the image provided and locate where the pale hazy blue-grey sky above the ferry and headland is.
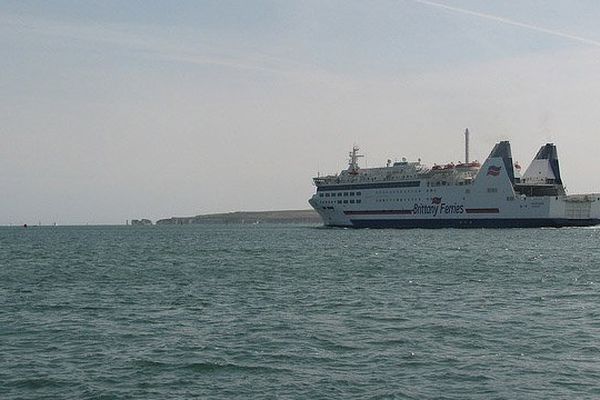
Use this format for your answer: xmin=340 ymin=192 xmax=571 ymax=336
xmin=0 ymin=0 xmax=600 ymax=224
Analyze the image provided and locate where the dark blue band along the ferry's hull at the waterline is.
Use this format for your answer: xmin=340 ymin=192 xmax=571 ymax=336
xmin=344 ymin=218 xmax=600 ymax=229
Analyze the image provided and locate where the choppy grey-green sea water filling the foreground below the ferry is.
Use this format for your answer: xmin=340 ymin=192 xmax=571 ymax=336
xmin=0 ymin=225 xmax=600 ymax=399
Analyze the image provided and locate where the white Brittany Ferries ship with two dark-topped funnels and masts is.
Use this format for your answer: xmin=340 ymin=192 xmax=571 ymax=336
xmin=309 ymin=129 xmax=600 ymax=228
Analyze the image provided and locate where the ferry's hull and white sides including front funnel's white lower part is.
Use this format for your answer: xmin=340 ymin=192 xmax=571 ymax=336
xmin=309 ymin=141 xmax=600 ymax=228
